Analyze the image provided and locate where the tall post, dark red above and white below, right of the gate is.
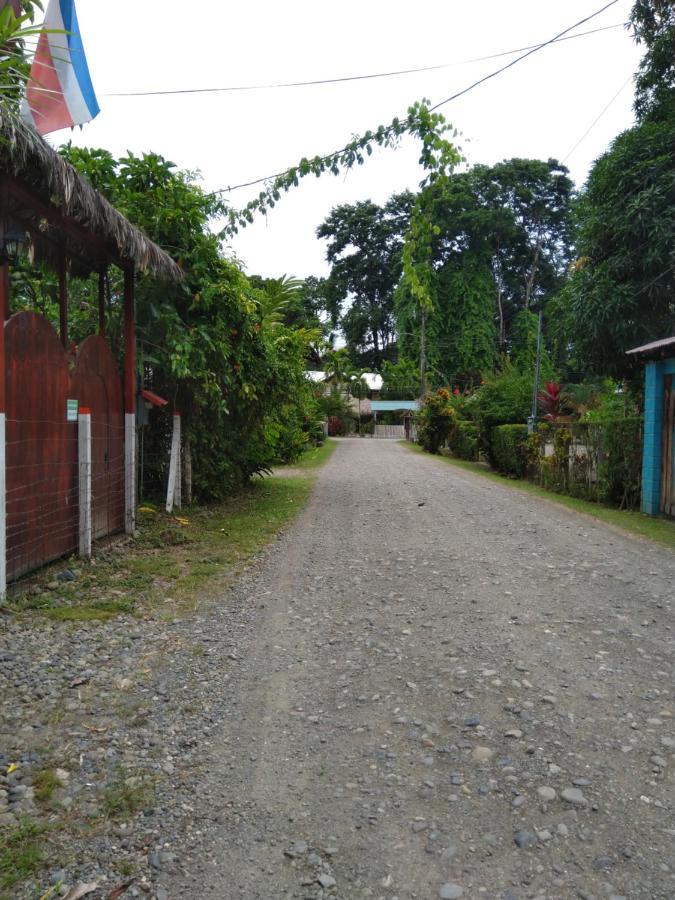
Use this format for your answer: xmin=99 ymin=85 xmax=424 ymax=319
xmin=124 ymin=266 xmax=136 ymax=534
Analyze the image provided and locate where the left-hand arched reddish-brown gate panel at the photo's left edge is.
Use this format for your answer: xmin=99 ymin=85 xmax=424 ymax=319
xmin=5 ymin=312 xmax=78 ymax=579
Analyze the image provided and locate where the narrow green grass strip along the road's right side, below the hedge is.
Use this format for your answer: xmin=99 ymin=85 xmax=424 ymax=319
xmin=400 ymin=441 xmax=675 ymax=550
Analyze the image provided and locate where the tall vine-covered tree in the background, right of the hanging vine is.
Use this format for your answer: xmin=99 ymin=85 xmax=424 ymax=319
xmin=396 ymin=159 xmax=572 ymax=381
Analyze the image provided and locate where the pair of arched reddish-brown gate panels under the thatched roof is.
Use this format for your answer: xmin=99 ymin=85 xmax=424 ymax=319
xmin=5 ymin=312 xmax=124 ymax=580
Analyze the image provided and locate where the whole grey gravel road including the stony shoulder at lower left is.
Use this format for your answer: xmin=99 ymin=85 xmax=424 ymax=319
xmin=5 ymin=439 xmax=675 ymax=900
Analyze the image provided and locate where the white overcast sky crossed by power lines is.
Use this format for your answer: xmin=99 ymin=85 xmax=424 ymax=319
xmin=50 ymin=0 xmax=640 ymax=277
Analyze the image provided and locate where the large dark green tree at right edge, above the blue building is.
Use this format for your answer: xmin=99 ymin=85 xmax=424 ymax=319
xmin=560 ymin=0 xmax=675 ymax=377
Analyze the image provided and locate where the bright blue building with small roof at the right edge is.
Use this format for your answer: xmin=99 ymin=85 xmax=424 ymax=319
xmin=628 ymin=337 xmax=675 ymax=516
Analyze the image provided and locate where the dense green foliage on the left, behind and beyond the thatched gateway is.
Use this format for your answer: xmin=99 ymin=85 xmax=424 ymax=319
xmin=14 ymin=146 xmax=322 ymax=499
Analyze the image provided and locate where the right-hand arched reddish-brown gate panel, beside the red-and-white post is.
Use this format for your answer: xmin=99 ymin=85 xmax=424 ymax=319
xmin=71 ymin=335 xmax=124 ymax=540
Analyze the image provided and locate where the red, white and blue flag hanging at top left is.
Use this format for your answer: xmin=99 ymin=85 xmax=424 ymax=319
xmin=21 ymin=0 xmax=99 ymax=134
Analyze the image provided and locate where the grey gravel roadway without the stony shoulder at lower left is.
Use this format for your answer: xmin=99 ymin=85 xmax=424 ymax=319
xmin=170 ymin=440 xmax=675 ymax=900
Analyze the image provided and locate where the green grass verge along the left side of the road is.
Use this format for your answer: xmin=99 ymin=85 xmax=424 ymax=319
xmin=8 ymin=440 xmax=337 ymax=622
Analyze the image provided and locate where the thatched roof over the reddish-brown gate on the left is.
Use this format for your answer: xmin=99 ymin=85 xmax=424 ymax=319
xmin=0 ymin=106 xmax=183 ymax=281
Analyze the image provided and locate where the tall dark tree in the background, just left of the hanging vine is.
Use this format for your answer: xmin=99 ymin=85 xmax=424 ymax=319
xmin=316 ymin=193 xmax=413 ymax=369
